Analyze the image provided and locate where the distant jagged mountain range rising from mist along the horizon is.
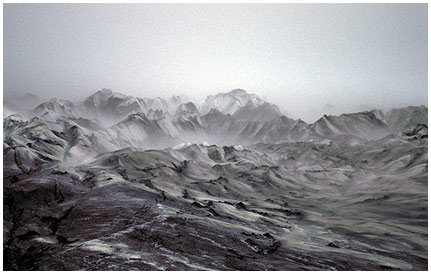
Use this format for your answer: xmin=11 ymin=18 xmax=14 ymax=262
xmin=3 ymin=89 xmax=428 ymax=150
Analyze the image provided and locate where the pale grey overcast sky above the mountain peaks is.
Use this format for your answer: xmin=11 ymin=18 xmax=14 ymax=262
xmin=3 ymin=4 xmax=428 ymax=122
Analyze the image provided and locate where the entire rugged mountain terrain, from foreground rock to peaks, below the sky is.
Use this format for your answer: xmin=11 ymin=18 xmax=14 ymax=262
xmin=3 ymin=89 xmax=428 ymax=270
